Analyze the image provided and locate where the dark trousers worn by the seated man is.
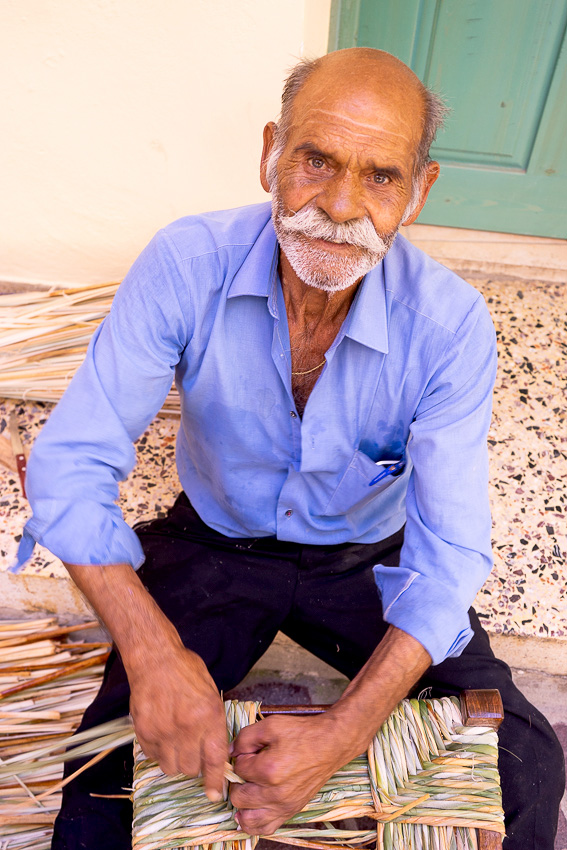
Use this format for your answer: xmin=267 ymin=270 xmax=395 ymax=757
xmin=52 ymin=494 xmax=564 ymax=850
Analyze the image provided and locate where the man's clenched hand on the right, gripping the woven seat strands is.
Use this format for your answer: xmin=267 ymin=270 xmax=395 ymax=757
xmin=230 ymin=714 xmax=349 ymax=835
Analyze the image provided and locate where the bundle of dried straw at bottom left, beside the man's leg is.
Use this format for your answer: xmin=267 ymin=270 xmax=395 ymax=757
xmin=0 ymin=618 xmax=112 ymax=850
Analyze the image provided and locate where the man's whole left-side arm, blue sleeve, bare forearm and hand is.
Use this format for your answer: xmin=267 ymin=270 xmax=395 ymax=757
xmin=17 ymin=234 xmax=231 ymax=796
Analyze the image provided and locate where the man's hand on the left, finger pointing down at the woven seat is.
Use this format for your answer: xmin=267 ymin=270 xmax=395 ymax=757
xmin=128 ymin=647 xmax=228 ymax=802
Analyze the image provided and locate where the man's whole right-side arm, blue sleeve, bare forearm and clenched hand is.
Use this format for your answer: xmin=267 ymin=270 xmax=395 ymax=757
xmin=231 ymin=299 xmax=496 ymax=833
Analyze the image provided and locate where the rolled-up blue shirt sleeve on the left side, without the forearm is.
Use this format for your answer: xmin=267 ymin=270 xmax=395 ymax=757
xmin=12 ymin=232 xmax=191 ymax=572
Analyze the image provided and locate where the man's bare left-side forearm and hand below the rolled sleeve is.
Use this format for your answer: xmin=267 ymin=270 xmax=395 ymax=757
xmin=66 ymin=564 xmax=228 ymax=800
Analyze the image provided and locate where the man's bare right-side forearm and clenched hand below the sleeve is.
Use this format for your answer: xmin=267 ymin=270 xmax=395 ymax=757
xmin=231 ymin=626 xmax=431 ymax=835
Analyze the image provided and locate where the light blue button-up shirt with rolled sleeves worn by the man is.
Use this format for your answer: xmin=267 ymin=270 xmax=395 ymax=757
xmin=15 ymin=204 xmax=496 ymax=663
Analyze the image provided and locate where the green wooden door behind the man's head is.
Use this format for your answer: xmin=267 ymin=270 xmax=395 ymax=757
xmin=330 ymin=0 xmax=567 ymax=238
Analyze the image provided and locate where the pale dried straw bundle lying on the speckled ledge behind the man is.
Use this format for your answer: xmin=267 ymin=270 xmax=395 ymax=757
xmin=0 ymin=283 xmax=179 ymax=415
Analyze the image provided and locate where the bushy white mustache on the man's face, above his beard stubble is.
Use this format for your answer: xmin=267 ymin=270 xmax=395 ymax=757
xmin=280 ymin=206 xmax=391 ymax=254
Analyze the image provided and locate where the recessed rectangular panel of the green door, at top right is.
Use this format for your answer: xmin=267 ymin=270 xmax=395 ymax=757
xmin=422 ymin=0 xmax=567 ymax=170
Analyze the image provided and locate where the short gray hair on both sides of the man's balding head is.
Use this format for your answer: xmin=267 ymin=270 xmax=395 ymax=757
xmin=270 ymin=59 xmax=450 ymax=181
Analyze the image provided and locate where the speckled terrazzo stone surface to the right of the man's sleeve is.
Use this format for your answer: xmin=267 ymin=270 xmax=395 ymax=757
xmin=473 ymin=281 xmax=567 ymax=639
